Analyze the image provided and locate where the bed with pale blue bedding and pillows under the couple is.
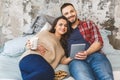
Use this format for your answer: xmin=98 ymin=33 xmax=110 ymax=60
xmin=0 ymin=15 xmax=120 ymax=80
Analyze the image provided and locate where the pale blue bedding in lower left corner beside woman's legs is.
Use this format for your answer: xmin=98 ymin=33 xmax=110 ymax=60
xmin=0 ymin=54 xmax=22 ymax=80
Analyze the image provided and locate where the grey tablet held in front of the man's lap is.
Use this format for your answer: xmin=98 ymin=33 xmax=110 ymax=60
xmin=70 ymin=44 xmax=85 ymax=58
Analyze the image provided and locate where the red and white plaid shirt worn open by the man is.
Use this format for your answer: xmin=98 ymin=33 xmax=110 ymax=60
xmin=78 ymin=21 xmax=103 ymax=45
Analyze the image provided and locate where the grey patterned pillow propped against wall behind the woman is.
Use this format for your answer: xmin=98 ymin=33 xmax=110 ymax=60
xmin=24 ymin=14 xmax=55 ymax=35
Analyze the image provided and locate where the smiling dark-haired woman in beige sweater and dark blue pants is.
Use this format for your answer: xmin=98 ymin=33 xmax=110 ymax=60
xmin=19 ymin=16 xmax=71 ymax=80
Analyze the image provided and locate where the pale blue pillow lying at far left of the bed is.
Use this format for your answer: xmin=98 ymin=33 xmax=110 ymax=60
xmin=2 ymin=36 xmax=31 ymax=57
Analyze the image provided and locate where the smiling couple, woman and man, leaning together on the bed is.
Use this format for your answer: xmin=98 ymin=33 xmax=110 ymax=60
xmin=19 ymin=3 xmax=114 ymax=80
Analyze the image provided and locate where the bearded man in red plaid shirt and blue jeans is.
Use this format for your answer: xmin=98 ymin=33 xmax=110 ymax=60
xmin=61 ymin=3 xmax=114 ymax=80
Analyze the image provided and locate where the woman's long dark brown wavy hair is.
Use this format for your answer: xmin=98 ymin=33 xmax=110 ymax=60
xmin=49 ymin=16 xmax=72 ymax=56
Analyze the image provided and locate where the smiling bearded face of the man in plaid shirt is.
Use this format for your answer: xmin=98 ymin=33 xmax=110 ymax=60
xmin=62 ymin=5 xmax=77 ymax=24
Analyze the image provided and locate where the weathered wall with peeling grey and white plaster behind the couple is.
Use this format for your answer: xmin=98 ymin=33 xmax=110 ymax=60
xmin=0 ymin=0 xmax=120 ymax=49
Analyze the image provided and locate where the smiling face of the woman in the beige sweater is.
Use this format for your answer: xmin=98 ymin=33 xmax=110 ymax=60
xmin=55 ymin=19 xmax=68 ymax=36
